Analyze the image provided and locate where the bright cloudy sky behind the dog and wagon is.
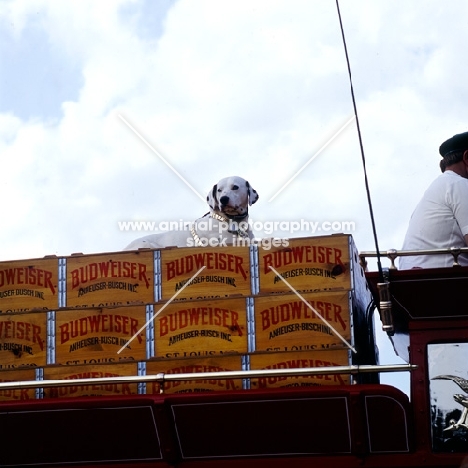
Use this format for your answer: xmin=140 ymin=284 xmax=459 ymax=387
xmin=0 ymin=0 xmax=468 ymax=394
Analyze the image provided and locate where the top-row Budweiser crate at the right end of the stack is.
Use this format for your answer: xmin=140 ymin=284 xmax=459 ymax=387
xmin=258 ymin=235 xmax=352 ymax=294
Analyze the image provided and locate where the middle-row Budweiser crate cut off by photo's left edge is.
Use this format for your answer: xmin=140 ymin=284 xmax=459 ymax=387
xmin=0 ymin=312 xmax=48 ymax=370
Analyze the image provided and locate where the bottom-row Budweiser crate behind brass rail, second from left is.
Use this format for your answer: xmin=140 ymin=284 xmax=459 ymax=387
xmin=44 ymin=363 xmax=138 ymax=398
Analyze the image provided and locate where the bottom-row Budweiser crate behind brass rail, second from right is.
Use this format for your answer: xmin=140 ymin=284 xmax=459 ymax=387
xmin=146 ymin=356 xmax=242 ymax=393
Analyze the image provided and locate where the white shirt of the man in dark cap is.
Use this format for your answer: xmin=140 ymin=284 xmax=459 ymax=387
xmin=399 ymin=170 xmax=468 ymax=270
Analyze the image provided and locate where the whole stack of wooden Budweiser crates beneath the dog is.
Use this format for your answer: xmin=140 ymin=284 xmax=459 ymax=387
xmin=0 ymin=235 xmax=376 ymax=400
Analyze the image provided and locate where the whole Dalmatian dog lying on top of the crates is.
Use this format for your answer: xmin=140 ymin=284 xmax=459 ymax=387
xmin=124 ymin=176 xmax=258 ymax=250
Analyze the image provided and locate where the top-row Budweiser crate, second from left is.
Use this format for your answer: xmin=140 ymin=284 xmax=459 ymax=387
xmin=63 ymin=251 xmax=155 ymax=307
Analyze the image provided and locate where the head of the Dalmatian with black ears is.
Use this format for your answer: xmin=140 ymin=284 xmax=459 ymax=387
xmin=206 ymin=176 xmax=258 ymax=218
